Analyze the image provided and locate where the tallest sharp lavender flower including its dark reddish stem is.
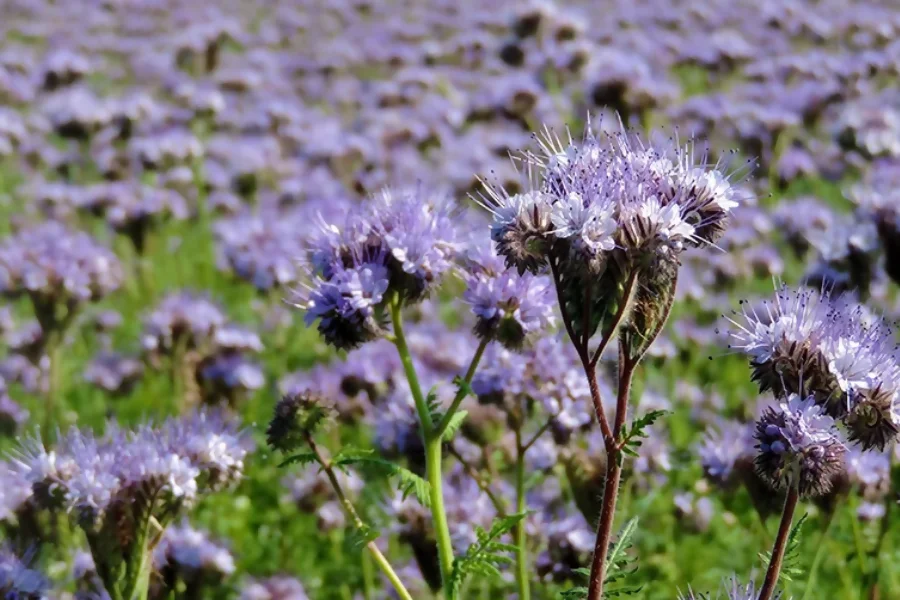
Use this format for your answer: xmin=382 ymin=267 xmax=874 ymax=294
xmin=480 ymin=123 xmax=742 ymax=600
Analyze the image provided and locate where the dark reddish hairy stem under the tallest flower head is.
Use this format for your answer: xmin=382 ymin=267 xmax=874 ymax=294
xmin=588 ymin=352 xmax=636 ymax=600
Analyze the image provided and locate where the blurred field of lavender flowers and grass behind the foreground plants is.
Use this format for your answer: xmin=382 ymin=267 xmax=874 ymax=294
xmin=0 ymin=0 xmax=900 ymax=600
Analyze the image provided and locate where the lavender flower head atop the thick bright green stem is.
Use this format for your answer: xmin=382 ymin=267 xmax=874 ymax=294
xmin=296 ymin=190 xmax=457 ymax=349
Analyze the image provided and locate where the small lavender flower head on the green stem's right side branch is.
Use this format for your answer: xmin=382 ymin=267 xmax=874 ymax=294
xmin=463 ymin=243 xmax=556 ymax=349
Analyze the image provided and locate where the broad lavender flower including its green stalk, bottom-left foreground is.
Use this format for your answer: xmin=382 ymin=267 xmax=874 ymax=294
xmin=14 ymin=412 xmax=252 ymax=600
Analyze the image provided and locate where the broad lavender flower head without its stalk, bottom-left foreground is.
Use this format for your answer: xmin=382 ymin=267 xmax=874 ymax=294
xmin=13 ymin=412 xmax=252 ymax=528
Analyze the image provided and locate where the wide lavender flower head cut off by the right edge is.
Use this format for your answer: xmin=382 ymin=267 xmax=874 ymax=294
xmin=731 ymin=288 xmax=900 ymax=448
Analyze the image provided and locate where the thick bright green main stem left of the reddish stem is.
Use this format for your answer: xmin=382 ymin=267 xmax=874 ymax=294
xmin=391 ymin=296 xmax=456 ymax=600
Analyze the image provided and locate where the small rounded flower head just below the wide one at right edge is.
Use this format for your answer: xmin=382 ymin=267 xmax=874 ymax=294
xmin=755 ymin=395 xmax=846 ymax=497
